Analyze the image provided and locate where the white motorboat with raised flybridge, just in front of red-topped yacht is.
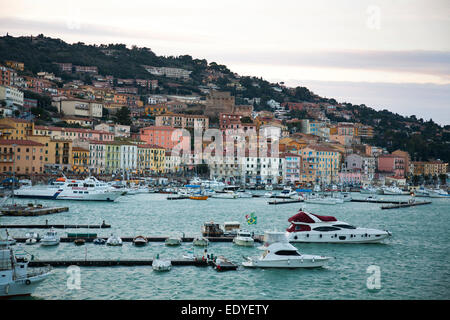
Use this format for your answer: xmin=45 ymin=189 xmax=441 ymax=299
xmin=242 ymin=232 xmax=331 ymax=268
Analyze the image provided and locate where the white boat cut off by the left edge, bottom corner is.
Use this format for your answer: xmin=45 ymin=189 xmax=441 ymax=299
xmin=0 ymin=245 xmax=51 ymax=297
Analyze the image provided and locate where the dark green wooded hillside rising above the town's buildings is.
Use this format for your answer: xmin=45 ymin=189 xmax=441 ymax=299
xmin=0 ymin=35 xmax=450 ymax=162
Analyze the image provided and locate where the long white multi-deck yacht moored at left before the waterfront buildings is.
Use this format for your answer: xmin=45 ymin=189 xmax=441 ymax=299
xmin=14 ymin=177 xmax=121 ymax=201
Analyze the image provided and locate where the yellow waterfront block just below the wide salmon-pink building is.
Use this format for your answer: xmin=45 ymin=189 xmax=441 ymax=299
xmin=137 ymin=144 xmax=166 ymax=173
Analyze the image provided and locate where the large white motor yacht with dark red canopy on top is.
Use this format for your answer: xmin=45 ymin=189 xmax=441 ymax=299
xmin=286 ymin=210 xmax=391 ymax=243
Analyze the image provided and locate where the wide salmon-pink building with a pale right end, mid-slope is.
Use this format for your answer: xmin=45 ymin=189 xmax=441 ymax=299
xmin=140 ymin=126 xmax=190 ymax=150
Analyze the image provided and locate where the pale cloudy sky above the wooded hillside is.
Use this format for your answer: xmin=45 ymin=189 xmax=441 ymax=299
xmin=0 ymin=0 xmax=450 ymax=125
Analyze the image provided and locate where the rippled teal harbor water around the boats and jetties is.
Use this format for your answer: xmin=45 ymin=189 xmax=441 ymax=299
xmin=0 ymin=193 xmax=450 ymax=300
